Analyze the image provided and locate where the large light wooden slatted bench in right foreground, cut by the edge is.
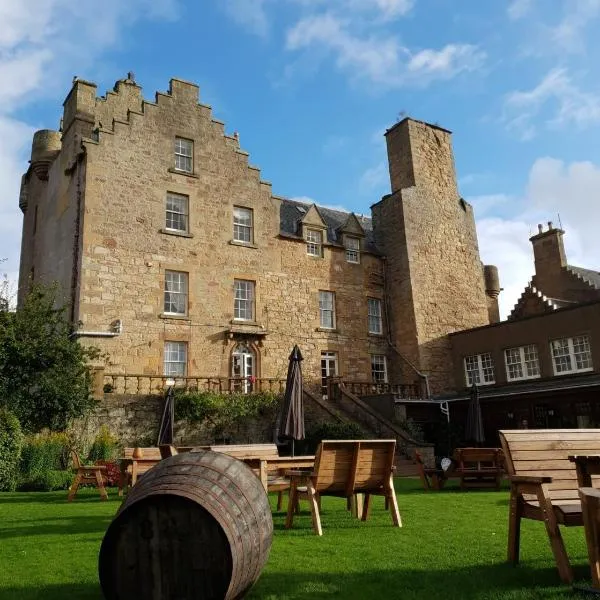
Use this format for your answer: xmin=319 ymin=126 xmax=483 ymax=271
xmin=499 ymin=429 xmax=600 ymax=583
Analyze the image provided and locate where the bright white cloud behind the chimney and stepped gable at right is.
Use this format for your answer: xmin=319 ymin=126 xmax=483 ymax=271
xmin=468 ymin=157 xmax=600 ymax=316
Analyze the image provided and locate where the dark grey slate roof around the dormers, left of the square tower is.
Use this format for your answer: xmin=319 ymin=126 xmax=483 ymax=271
xmin=279 ymin=198 xmax=381 ymax=254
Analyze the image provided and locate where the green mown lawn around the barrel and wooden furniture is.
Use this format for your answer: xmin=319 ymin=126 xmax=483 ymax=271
xmin=0 ymin=479 xmax=589 ymax=600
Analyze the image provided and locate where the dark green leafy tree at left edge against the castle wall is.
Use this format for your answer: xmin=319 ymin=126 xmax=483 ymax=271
xmin=0 ymin=284 xmax=99 ymax=431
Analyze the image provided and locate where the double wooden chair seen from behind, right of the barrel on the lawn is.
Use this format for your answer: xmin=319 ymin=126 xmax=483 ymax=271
xmin=285 ymin=440 xmax=402 ymax=535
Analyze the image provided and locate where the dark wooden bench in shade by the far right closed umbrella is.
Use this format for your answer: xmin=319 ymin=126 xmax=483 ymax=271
xmin=448 ymin=448 xmax=504 ymax=490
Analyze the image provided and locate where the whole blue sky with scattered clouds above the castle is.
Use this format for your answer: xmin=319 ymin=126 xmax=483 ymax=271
xmin=0 ymin=0 xmax=600 ymax=314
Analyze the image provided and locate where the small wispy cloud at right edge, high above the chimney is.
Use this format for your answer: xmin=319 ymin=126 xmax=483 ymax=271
xmin=504 ymin=68 xmax=600 ymax=140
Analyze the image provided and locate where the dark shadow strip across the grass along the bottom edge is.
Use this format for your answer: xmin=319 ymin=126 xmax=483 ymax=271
xmin=248 ymin=564 xmax=589 ymax=600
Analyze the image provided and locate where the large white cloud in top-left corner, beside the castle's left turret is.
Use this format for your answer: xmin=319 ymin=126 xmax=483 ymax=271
xmin=0 ymin=0 xmax=178 ymax=282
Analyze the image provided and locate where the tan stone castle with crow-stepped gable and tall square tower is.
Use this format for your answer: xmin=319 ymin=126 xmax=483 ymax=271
xmin=19 ymin=74 xmax=500 ymax=393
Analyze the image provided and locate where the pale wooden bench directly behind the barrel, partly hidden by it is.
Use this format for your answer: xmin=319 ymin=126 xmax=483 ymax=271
xmin=209 ymin=444 xmax=290 ymax=511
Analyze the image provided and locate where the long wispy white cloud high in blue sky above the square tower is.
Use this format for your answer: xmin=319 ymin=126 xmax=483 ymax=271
xmin=286 ymin=12 xmax=485 ymax=88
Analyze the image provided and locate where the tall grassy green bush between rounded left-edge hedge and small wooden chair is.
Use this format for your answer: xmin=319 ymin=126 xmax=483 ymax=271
xmin=19 ymin=430 xmax=71 ymax=489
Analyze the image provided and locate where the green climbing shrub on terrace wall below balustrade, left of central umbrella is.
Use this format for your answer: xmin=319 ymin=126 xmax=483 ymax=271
xmin=175 ymin=391 xmax=281 ymax=435
